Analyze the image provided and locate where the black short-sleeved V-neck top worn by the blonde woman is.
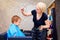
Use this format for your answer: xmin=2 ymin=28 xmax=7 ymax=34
xmin=31 ymin=10 xmax=48 ymax=28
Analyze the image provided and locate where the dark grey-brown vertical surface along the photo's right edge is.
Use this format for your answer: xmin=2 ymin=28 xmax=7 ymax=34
xmin=55 ymin=0 xmax=60 ymax=40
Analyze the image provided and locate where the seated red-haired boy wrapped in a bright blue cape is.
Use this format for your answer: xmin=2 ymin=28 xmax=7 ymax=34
xmin=7 ymin=15 xmax=25 ymax=37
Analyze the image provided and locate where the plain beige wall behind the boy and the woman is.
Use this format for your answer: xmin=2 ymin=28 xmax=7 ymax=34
xmin=0 ymin=0 xmax=54 ymax=33
